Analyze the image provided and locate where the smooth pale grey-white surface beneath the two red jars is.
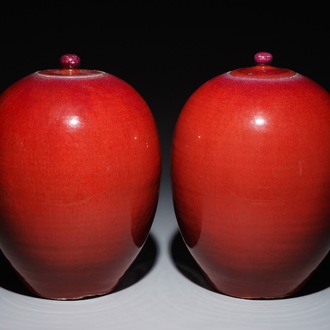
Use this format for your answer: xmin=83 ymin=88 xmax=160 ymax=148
xmin=0 ymin=179 xmax=330 ymax=330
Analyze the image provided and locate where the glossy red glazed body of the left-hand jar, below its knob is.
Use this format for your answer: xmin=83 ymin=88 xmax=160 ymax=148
xmin=0 ymin=56 xmax=161 ymax=299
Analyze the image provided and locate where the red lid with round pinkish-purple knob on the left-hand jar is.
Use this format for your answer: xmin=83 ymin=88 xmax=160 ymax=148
xmin=36 ymin=54 xmax=106 ymax=78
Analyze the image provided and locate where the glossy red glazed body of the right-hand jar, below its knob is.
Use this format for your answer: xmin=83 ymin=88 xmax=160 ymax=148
xmin=171 ymin=52 xmax=330 ymax=298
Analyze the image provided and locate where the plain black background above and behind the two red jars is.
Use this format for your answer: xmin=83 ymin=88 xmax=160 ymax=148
xmin=0 ymin=0 xmax=330 ymax=175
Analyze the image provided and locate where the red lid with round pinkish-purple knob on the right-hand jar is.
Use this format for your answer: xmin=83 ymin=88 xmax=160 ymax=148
xmin=228 ymin=52 xmax=298 ymax=79
